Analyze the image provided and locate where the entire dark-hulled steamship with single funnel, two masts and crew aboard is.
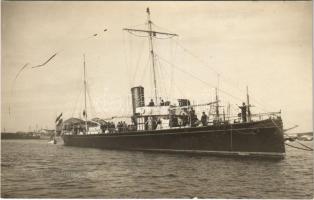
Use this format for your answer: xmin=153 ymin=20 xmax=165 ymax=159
xmin=57 ymin=8 xmax=285 ymax=158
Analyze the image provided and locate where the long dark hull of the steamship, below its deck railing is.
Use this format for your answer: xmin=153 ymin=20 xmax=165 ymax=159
xmin=62 ymin=118 xmax=285 ymax=159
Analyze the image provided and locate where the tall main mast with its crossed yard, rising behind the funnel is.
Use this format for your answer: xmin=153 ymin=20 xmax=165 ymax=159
xmin=123 ymin=8 xmax=178 ymax=104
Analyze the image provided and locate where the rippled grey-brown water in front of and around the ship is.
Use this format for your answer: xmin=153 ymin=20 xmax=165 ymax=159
xmin=1 ymin=140 xmax=313 ymax=199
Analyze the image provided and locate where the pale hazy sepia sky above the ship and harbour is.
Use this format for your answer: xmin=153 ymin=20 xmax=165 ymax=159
xmin=1 ymin=1 xmax=313 ymax=132
